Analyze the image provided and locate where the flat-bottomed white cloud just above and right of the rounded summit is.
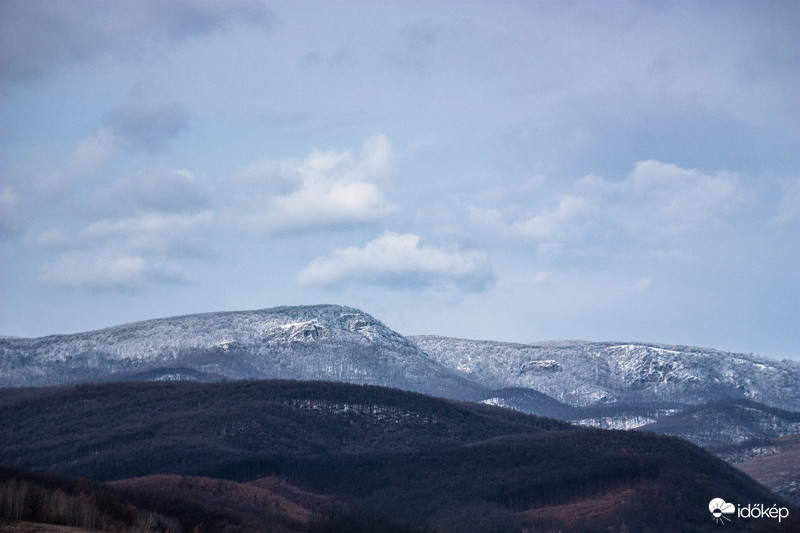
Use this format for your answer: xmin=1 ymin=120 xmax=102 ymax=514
xmin=299 ymin=232 xmax=494 ymax=291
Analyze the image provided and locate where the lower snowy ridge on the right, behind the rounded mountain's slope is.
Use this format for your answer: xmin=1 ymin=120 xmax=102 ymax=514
xmin=409 ymin=336 xmax=800 ymax=411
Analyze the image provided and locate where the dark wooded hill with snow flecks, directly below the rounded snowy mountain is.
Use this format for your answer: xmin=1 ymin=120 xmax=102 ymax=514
xmin=0 ymin=381 xmax=569 ymax=480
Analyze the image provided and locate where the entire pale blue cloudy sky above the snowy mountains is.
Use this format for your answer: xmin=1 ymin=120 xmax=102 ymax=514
xmin=0 ymin=0 xmax=800 ymax=359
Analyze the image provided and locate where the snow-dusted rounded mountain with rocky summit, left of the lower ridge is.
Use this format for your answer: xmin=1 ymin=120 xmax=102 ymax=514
xmin=0 ymin=305 xmax=482 ymax=399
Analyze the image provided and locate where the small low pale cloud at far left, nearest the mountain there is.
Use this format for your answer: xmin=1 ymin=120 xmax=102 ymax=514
xmin=39 ymin=250 xmax=182 ymax=290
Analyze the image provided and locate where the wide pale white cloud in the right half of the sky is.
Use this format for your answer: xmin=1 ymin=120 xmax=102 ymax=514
xmin=462 ymin=160 xmax=744 ymax=256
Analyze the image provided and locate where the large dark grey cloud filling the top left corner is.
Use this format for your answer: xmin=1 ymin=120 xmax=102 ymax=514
xmin=0 ymin=0 xmax=274 ymax=82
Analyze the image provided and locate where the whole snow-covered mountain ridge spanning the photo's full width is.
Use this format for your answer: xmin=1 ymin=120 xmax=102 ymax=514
xmin=0 ymin=305 xmax=800 ymax=416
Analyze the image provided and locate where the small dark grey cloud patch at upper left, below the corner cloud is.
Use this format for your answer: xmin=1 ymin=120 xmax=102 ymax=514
xmin=107 ymin=102 xmax=189 ymax=153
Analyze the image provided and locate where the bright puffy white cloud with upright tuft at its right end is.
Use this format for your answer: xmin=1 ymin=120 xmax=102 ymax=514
xmin=225 ymin=135 xmax=396 ymax=233
